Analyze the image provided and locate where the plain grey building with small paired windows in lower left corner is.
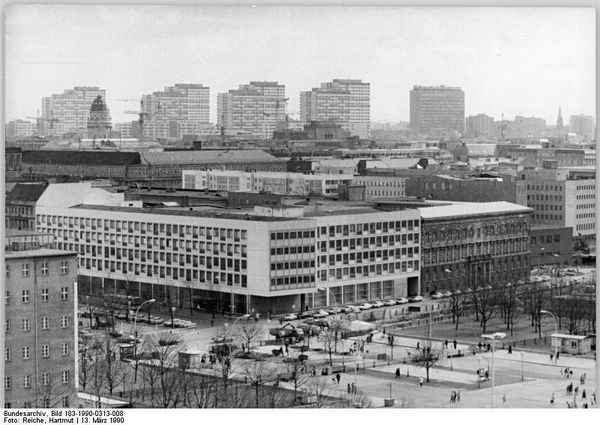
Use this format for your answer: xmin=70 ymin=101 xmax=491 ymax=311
xmin=4 ymin=243 xmax=79 ymax=409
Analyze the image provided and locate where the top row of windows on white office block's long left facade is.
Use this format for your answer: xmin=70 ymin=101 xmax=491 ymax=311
xmin=37 ymin=214 xmax=248 ymax=241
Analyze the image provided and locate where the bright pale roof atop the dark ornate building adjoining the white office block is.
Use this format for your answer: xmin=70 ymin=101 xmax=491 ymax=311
xmin=419 ymin=201 xmax=533 ymax=220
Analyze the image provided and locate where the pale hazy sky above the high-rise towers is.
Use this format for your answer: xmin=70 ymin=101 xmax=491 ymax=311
xmin=5 ymin=5 xmax=596 ymax=124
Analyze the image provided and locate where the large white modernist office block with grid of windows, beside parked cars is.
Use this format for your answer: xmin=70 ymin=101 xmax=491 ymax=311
xmin=36 ymin=183 xmax=420 ymax=313
